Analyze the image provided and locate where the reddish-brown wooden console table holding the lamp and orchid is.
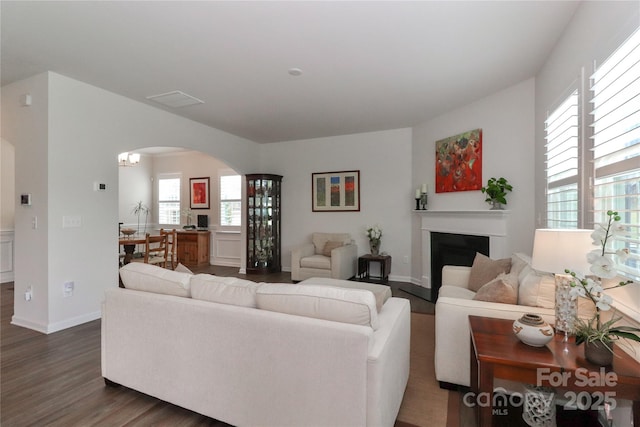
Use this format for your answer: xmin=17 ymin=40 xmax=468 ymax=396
xmin=469 ymin=316 xmax=640 ymax=427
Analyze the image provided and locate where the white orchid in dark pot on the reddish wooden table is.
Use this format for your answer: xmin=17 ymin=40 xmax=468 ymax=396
xmin=565 ymin=211 xmax=640 ymax=365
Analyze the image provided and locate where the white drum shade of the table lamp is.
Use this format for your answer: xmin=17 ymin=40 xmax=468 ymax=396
xmin=531 ymin=229 xmax=595 ymax=275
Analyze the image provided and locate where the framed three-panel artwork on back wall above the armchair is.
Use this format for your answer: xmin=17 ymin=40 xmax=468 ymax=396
xmin=311 ymin=170 xmax=360 ymax=212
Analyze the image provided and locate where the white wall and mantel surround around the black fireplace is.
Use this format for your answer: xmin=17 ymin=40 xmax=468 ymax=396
xmin=411 ymin=79 xmax=535 ymax=283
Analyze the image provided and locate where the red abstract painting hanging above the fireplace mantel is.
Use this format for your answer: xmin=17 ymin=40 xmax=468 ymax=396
xmin=436 ymin=129 xmax=482 ymax=193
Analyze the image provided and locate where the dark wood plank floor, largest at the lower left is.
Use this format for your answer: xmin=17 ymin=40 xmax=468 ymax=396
xmin=0 ymin=267 xmax=433 ymax=427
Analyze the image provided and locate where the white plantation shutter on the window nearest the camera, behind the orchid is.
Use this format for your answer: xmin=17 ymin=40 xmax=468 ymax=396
xmin=591 ymin=27 xmax=640 ymax=279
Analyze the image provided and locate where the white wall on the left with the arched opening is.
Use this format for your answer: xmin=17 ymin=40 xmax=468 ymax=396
xmin=2 ymin=72 xmax=257 ymax=332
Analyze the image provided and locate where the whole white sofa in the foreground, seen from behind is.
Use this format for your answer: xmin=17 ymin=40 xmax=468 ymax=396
xmin=102 ymin=263 xmax=410 ymax=427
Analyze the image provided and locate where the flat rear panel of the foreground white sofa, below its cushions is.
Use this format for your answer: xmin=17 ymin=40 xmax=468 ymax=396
xmin=102 ymin=289 xmax=376 ymax=426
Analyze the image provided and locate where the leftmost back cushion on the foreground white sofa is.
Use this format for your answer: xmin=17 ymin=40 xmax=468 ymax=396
xmin=120 ymin=262 xmax=192 ymax=298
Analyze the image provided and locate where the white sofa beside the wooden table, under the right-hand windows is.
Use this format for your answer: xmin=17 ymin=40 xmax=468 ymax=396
xmin=435 ymin=254 xmax=555 ymax=388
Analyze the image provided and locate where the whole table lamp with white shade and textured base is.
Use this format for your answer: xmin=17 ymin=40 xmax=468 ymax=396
xmin=531 ymin=229 xmax=594 ymax=339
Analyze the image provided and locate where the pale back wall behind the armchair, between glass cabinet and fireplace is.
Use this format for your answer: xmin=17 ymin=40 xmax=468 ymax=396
xmin=262 ymin=129 xmax=415 ymax=281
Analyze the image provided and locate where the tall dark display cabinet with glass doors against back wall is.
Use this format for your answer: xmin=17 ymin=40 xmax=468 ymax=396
xmin=246 ymin=174 xmax=282 ymax=273
